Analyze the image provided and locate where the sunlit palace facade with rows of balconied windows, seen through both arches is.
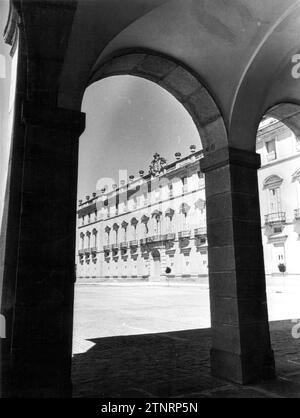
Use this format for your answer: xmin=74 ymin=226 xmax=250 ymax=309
xmin=76 ymin=118 xmax=300 ymax=283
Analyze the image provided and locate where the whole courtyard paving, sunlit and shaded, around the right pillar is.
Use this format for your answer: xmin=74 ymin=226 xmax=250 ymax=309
xmin=73 ymin=285 xmax=300 ymax=398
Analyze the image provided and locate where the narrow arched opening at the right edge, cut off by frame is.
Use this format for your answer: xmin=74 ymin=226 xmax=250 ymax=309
xmin=256 ymin=103 xmax=300 ymax=378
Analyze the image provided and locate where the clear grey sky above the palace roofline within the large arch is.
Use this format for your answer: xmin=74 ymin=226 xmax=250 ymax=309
xmin=78 ymin=76 xmax=201 ymax=199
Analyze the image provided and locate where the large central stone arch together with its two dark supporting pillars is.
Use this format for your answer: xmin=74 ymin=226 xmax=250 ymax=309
xmin=2 ymin=41 xmax=274 ymax=397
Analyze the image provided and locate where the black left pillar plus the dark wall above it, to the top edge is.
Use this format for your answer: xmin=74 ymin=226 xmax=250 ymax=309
xmin=0 ymin=0 xmax=85 ymax=397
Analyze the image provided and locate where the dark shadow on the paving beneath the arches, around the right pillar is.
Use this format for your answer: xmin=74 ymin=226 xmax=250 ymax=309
xmin=73 ymin=321 xmax=300 ymax=398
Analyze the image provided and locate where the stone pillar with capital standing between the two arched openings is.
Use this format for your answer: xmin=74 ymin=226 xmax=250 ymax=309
xmin=200 ymin=147 xmax=275 ymax=384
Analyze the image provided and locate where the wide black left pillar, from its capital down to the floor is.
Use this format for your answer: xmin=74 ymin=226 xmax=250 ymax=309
xmin=0 ymin=99 xmax=85 ymax=397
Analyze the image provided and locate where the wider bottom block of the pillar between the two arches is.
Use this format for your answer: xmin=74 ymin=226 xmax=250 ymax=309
xmin=210 ymin=348 xmax=276 ymax=385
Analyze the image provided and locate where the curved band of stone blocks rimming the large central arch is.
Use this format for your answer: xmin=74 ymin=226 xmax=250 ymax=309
xmin=87 ymin=51 xmax=228 ymax=155
